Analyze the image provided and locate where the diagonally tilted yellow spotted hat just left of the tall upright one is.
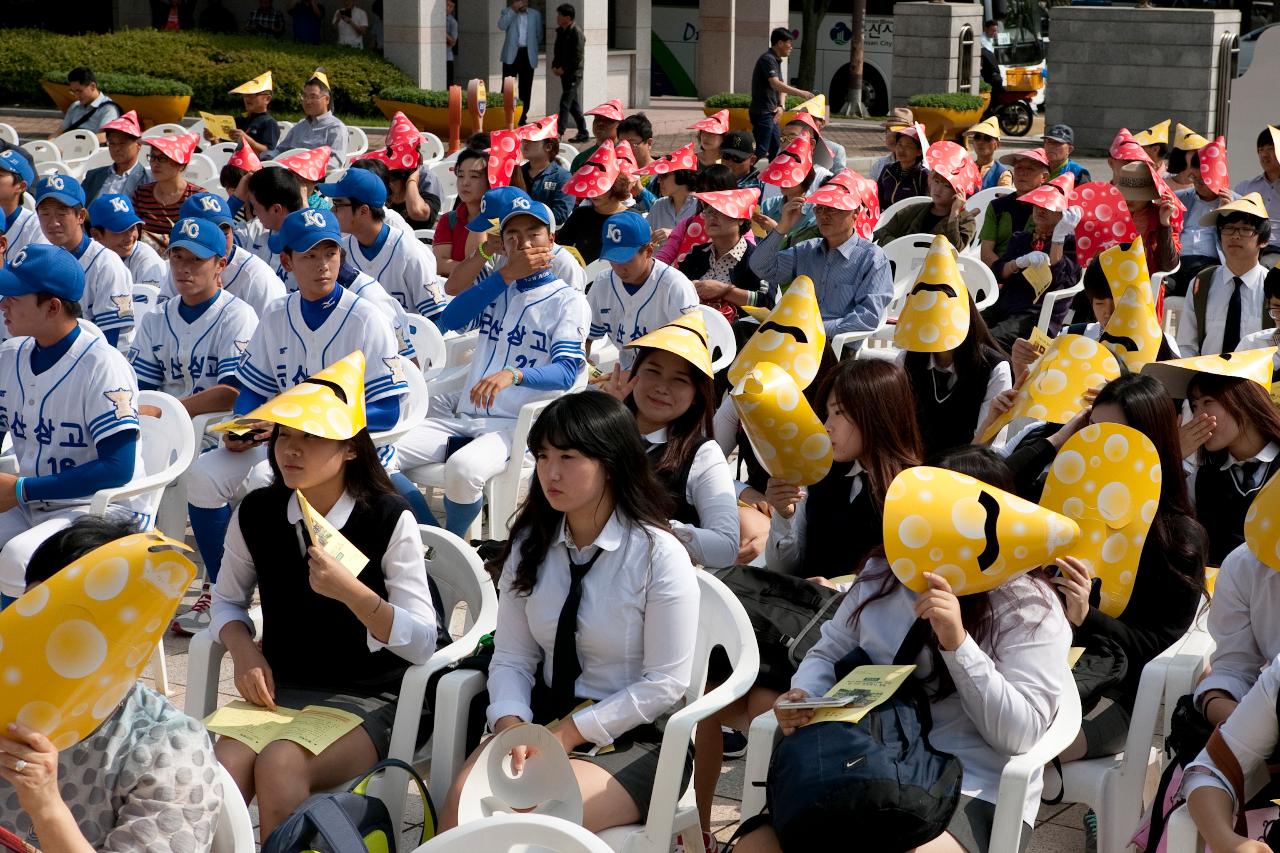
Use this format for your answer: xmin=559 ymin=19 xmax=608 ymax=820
xmin=978 ymin=334 xmax=1120 ymax=443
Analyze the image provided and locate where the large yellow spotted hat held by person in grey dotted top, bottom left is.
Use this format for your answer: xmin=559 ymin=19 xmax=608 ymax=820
xmin=0 ymin=533 xmax=196 ymax=751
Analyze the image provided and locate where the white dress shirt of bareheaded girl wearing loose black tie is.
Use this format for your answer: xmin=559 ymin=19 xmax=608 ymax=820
xmin=489 ymin=512 xmax=699 ymax=745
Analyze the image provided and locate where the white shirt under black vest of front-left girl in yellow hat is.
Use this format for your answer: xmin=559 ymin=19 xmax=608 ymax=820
xmin=209 ymin=492 xmax=436 ymax=663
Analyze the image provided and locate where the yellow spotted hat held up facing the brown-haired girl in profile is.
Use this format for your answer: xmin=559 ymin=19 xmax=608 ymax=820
xmin=730 ymin=361 xmax=832 ymax=485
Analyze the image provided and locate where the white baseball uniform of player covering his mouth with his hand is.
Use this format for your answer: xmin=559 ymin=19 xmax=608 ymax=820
xmin=396 ymin=272 xmax=590 ymax=503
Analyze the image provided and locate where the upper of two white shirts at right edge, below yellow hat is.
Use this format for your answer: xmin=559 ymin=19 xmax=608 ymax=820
xmin=1196 ymin=544 xmax=1280 ymax=711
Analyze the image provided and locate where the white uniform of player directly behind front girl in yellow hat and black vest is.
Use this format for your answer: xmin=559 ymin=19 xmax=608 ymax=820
xmin=187 ymin=287 xmax=408 ymax=508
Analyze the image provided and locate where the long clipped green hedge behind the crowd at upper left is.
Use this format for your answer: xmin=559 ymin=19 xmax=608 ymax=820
xmin=0 ymin=29 xmax=412 ymax=119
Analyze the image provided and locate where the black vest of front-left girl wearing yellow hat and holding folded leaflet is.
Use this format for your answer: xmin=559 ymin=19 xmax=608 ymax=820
xmin=239 ymin=488 xmax=408 ymax=695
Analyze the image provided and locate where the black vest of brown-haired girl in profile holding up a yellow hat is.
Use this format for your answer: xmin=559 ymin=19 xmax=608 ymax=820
xmin=799 ymin=462 xmax=884 ymax=578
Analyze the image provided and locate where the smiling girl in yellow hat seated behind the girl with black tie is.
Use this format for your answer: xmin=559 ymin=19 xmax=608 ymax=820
xmin=602 ymin=311 xmax=739 ymax=569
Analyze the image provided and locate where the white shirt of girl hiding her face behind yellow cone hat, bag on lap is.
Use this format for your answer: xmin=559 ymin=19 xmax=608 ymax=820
xmin=791 ymin=558 xmax=1070 ymax=826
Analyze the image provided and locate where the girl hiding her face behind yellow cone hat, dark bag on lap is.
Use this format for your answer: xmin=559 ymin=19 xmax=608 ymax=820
xmin=736 ymin=447 xmax=1075 ymax=853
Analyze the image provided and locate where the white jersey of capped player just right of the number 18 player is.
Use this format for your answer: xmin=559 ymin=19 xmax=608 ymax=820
xmin=129 ymin=291 xmax=257 ymax=400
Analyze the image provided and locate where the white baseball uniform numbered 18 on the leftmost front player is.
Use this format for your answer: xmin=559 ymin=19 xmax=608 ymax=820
xmin=0 ymin=327 xmax=146 ymax=597
